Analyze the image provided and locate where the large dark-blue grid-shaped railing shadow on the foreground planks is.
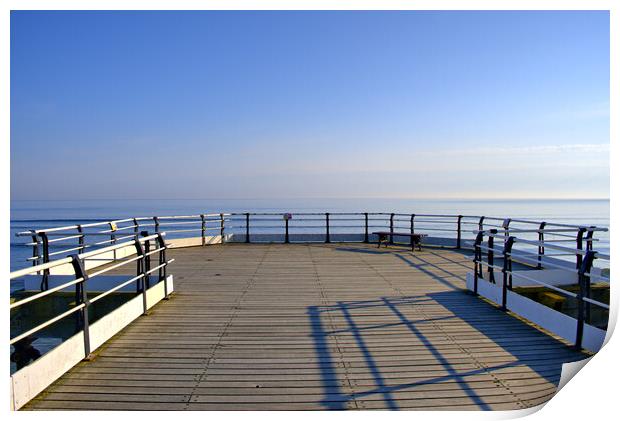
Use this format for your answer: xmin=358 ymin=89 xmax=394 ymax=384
xmin=307 ymin=291 xmax=585 ymax=410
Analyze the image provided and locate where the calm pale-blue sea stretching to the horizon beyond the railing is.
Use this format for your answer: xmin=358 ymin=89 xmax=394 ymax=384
xmin=11 ymin=199 xmax=609 ymax=270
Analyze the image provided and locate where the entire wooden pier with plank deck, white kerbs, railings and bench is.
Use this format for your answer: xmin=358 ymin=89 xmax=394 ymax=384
xmin=13 ymin=213 xmax=608 ymax=410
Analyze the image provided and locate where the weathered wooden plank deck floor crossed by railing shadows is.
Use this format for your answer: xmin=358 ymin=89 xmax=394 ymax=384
xmin=25 ymin=244 xmax=586 ymax=410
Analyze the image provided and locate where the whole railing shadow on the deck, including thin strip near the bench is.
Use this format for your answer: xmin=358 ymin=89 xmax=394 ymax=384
xmin=307 ymin=247 xmax=587 ymax=410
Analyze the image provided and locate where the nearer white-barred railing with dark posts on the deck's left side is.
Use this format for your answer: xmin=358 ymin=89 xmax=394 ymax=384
xmin=9 ymin=230 xmax=174 ymax=356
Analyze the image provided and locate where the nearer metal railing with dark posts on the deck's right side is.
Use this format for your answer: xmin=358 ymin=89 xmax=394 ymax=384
xmin=472 ymin=228 xmax=611 ymax=349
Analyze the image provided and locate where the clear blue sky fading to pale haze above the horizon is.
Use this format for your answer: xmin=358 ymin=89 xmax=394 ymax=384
xmin=11 ymin=11 xmax=610 ymax=199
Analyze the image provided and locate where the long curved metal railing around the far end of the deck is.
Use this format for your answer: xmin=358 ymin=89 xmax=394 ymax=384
xmin=16 ymin=212 xmax=607 ymax=268
